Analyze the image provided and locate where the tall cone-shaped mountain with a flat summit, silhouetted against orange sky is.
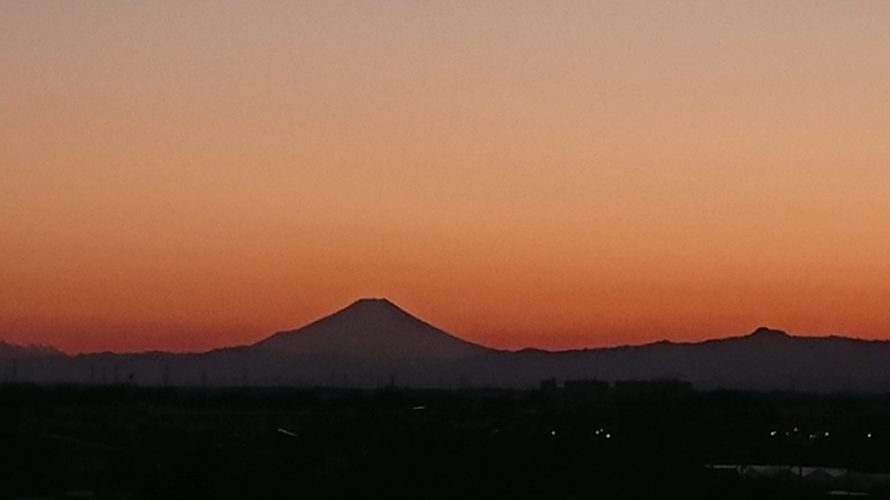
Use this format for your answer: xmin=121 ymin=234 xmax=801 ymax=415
xmin=252 ymin=299 xmax=489 ymax=360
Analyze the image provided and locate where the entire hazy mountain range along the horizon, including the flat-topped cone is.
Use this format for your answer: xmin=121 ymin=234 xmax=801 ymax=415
xmin=0 ymin=299 xmax=890 ymax=392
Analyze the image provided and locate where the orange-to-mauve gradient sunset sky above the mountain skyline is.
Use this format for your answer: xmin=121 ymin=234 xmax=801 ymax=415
xmin=0 ymin=0 xmax=890 ymax=352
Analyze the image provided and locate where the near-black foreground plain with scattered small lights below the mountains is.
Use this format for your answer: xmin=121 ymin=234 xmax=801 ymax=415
xmin=0 ymin=384 xmax=890 ymax=499
